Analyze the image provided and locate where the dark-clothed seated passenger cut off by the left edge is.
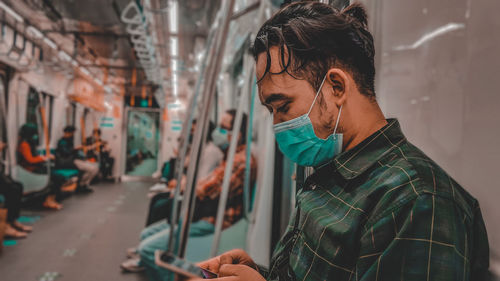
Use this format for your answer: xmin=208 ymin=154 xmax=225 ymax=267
xmin=0 ymin=141 xmax=32 ymax=239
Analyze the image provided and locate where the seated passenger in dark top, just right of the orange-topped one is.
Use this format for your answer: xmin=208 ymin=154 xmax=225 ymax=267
xmin=56 ymin=126 xmax=99 ymax=193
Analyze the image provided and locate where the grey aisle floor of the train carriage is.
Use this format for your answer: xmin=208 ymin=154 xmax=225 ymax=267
xmin=0 ymin=182 xmax=151 ymax=281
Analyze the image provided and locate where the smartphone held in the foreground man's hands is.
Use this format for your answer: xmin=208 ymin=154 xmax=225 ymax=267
xmin=155 ymin=250 xmax=219 ymax=279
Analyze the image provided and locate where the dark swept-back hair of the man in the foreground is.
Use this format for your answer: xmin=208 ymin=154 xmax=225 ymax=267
xmin=252 ymin=1 xmax=375 ymax=98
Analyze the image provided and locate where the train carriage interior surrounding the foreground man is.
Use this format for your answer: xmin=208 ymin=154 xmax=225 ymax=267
xmin=0 ymin=0 xmax=500 ymax=281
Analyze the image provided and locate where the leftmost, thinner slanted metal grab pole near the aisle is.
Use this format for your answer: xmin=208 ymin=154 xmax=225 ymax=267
xmin=167 ymin=18 xmax=219 ymax=253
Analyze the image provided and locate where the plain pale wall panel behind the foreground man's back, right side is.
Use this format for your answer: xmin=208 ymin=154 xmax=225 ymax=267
xmin=364 ymin=0 xmax=500 ymax=272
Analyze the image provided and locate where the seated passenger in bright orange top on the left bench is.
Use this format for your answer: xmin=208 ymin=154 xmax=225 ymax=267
xmin=17 ymin=123 xmax=62 ymax=210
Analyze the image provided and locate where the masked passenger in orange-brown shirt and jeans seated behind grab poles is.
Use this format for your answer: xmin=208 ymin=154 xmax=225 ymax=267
xmin=121 ymin=110 xmax=256 ymax=280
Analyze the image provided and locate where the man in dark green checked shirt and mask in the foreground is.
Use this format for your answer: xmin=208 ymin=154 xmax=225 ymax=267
xmin=195 ymin=1 xmax=489 ymax=281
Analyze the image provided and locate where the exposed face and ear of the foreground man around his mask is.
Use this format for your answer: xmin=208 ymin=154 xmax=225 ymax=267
xmin=256 ymin=47 xmax=338 ymax=138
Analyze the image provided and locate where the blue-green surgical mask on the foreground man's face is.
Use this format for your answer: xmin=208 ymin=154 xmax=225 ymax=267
xmin=274 ymin=75 xmax=342 ymax=167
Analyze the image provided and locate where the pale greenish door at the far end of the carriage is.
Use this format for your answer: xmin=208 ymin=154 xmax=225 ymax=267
xmin=122 ymin=108 xmax=160 ymax=178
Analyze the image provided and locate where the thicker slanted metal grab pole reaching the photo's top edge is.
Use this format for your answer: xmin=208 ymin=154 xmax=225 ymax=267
xmin=178 ymin=0 xmax=235 ymax=258
